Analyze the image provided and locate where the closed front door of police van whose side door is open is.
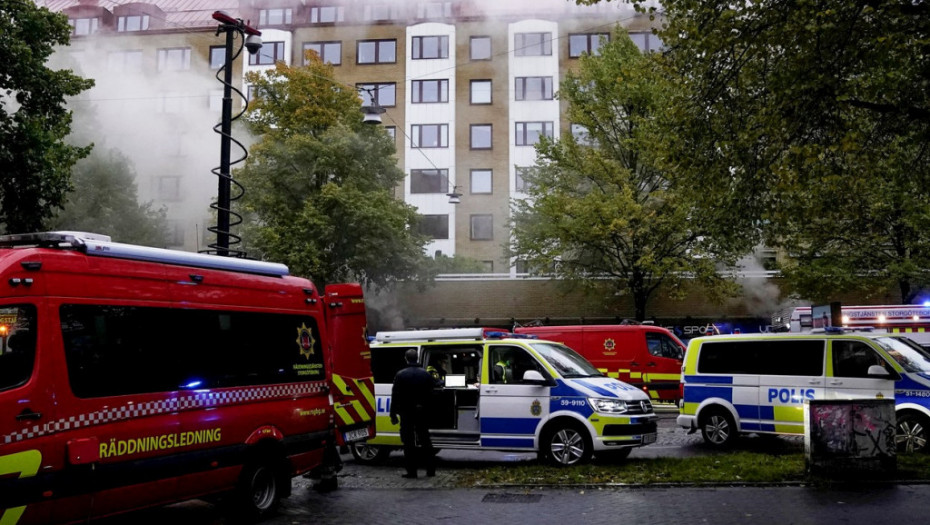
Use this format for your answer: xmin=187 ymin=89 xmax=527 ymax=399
xmin=478 ymin=344 xmax=550 ymax=450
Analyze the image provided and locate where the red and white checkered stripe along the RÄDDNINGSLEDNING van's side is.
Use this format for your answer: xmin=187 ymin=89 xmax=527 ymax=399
xmin=0 ymin=381 xmax=327 ymax=444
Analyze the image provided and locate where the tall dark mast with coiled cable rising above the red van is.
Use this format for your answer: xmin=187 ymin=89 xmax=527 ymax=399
xmin=207 ymin=11 xmax=262 ymax=256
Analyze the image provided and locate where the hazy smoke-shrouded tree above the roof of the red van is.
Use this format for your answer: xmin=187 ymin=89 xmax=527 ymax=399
xmin=49 ymin=150 xmax=167 ymax=248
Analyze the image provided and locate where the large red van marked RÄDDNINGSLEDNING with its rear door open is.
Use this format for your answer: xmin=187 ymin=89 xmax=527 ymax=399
xmin=0 ymin=232 xmax=374 ymax=525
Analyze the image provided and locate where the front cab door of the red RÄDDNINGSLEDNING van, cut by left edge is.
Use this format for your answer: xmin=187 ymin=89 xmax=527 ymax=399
xmin=0 ymin=304 xmax=52 ymax=523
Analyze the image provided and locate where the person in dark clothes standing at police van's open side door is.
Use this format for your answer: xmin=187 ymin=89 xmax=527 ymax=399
xmin=391 ymin=348 xmax=436 ymax=478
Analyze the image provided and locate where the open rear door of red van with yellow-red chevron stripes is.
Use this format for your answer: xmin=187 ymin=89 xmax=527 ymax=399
xmin=325 ymin=284 xmax=375 ymax=446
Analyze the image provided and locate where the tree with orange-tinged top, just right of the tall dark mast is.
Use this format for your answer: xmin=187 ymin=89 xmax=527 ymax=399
xmin=237 ymin=53 xmax=428 ymax=287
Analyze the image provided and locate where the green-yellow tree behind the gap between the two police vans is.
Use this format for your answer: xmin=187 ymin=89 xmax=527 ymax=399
xmin=510 ymin=31 xmax=730 ymax=320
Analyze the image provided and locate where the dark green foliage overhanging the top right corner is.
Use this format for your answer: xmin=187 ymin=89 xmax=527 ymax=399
xmin=644 ymin=0 xmax=930 ymax=302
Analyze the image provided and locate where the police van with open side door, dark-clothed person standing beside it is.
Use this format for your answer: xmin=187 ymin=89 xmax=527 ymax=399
xmin=350 ymin=328 xmax=658 ymax=465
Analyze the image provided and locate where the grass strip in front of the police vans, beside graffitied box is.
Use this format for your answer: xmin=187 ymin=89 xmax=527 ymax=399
xmin=459 ymin=451 xmax=930 ymax=487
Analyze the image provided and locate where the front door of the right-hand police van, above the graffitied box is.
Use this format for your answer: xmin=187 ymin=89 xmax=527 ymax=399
xmin=827 ymin=339 xmax=894 ymax=399
